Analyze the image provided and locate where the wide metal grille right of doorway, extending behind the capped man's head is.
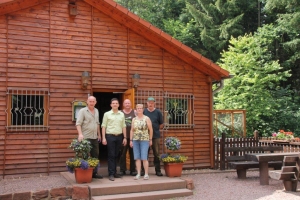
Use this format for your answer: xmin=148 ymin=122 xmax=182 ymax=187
xmin=135 ymin=90 xmax=195 ymax=130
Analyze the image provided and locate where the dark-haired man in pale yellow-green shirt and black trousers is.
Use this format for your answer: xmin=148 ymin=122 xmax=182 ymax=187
xmin=101 ymin=98 xmax=127 ymax=181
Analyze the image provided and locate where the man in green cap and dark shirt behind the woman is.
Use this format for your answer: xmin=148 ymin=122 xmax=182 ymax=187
xmin=144 ymin=97 xmax=163 ymax=176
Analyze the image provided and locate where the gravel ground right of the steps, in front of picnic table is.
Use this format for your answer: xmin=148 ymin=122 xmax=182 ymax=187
xmin=176 ymin=171 xmax=300 ymax=200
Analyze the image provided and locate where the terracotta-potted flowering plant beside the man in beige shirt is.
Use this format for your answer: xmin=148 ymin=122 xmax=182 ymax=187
xmin=66 ymin=139 xmax=99 ymax=183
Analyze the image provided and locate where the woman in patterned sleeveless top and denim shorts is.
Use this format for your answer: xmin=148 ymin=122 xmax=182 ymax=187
xmin=130 ymin=104 xmax=153 ymax=180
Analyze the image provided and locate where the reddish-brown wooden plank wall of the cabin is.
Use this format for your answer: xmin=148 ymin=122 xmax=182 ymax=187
xmin=0 ymin=0 xmax=213 ymax=177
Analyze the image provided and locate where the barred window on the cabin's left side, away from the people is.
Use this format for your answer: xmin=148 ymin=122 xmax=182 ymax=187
xmin=6 ymin=88 xmax=49 ymax=131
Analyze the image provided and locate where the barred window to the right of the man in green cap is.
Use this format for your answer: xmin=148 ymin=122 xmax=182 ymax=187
xmin=164 ymin=93 xmax=194 ymax=128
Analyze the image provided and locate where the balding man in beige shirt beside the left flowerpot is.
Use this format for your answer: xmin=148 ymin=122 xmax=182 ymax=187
xmin=76 ymin=96 xmax=103 ymax=179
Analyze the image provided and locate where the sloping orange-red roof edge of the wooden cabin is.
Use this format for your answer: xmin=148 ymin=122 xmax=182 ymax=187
xmin=0 ymin=0 xmax=229 ymax=80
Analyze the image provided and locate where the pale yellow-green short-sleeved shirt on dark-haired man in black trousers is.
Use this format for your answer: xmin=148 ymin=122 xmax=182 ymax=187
xmin=101 ymin=110 xmax=126 ymax=134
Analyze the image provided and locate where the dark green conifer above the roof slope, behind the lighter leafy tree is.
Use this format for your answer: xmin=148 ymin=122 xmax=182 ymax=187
xmin=187 ymin=0 xmax=257 ymax=61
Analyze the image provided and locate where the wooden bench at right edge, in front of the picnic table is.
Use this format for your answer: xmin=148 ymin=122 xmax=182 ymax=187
xmin=269 ymin=156 xmax=300 ymax=192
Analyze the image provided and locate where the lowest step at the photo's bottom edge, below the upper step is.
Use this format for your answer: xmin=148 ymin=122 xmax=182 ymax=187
xmin=92 ymin=189 xmax=193 ymax=200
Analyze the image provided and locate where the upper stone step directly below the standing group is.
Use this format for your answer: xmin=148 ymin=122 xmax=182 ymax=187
xmin=89 ymin=177 xmax=186 ymax=196
